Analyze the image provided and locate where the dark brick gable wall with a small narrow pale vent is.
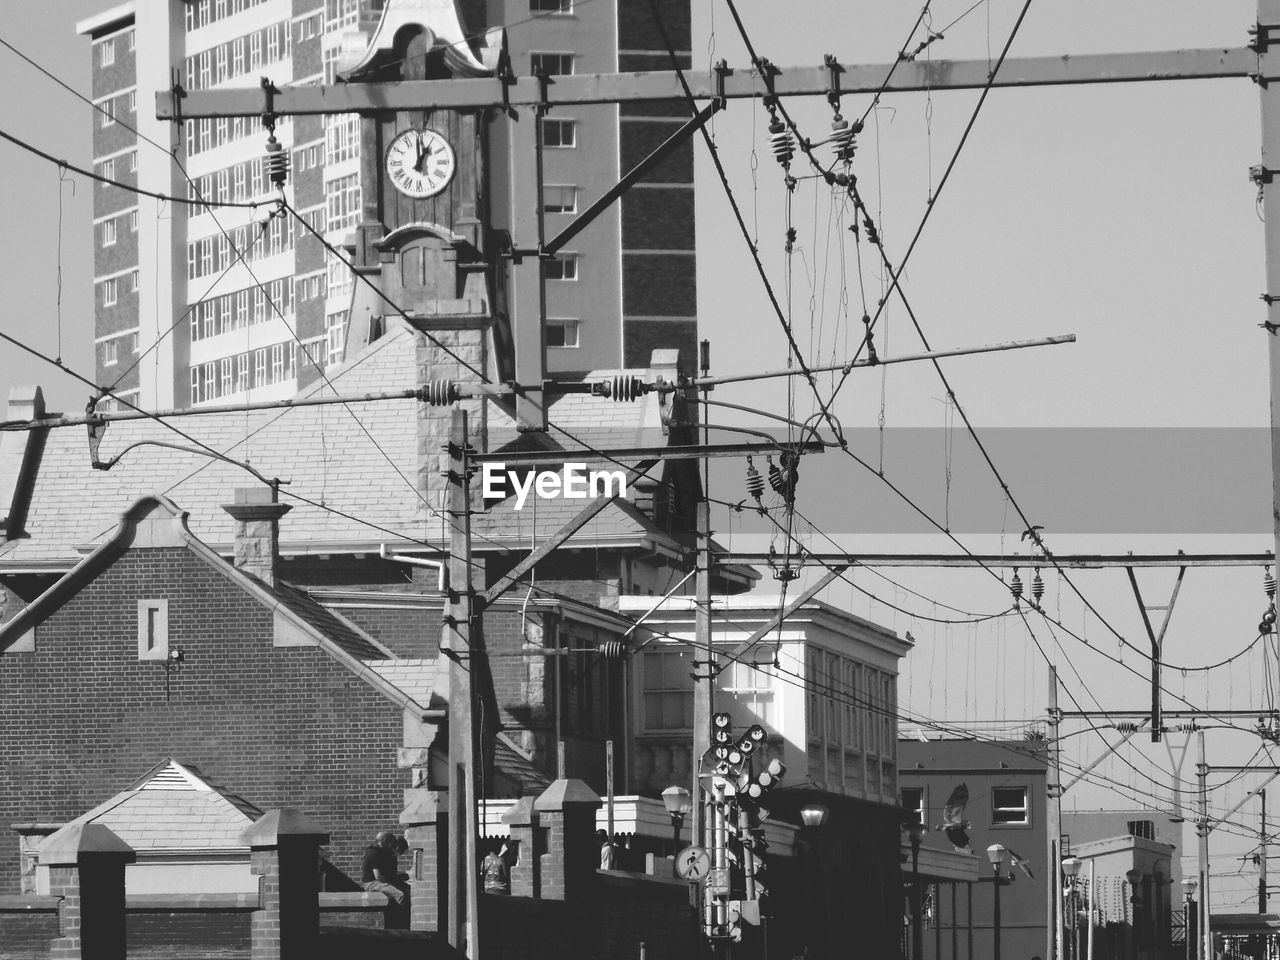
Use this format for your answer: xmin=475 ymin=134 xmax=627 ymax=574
xmin=0 ymin=548 xmax=407 ymax=893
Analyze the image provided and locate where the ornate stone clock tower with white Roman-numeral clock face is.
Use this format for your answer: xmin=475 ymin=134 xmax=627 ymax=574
xmin=339 ymin=0 xmax=511 ymax=514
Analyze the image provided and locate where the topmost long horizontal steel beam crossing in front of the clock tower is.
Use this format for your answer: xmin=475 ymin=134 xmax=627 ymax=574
xmin=156 ymin=47 xmax=1254 ymax=120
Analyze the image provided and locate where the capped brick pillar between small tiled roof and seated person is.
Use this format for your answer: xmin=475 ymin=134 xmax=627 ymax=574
xmin=239 ymin=806 xmax=329 ymax=960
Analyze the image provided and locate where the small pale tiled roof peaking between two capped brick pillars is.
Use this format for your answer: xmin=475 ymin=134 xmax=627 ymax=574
xmin=73 ymin=760 xmax=262 ymax=852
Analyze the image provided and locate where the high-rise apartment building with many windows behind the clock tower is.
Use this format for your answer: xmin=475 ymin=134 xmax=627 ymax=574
xmin=77 ymin=0 xmax=696 ymax=408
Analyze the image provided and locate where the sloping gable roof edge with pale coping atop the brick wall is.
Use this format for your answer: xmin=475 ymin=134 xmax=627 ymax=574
xmin=0 ymin=495 xmax=444 ymax=719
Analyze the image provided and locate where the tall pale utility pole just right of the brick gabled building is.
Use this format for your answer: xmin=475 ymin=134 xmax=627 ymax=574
xmin=440 ymin=408 xmax=488 ymax=960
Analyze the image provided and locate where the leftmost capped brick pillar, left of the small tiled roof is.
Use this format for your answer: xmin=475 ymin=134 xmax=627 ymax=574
xmin=40 ymin=823 xmax=136 ymax=960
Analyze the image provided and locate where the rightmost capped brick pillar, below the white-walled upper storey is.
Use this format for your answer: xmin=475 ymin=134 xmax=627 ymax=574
xmin=534 ymin=780 xmax=602 ymax=901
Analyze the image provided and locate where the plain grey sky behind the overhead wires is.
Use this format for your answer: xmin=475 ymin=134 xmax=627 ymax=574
xmin=0 ymin=0 xmax=1277 ymax=909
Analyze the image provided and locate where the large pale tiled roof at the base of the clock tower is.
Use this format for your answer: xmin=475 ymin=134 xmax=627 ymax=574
xmin=0 ymin=328 xmax=680 ymax=570
